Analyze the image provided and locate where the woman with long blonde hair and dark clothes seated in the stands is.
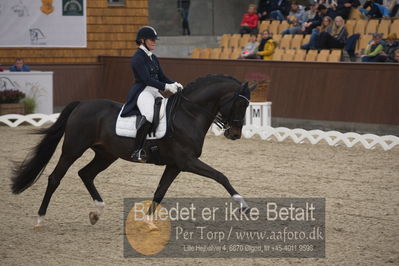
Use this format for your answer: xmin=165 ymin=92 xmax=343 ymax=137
xmin=318 ymin=16 xmax=348 ymax=49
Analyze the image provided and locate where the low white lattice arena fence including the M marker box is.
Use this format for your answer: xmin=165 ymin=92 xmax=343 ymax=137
xmin=0 ymin=102 xmax=399 ymax=150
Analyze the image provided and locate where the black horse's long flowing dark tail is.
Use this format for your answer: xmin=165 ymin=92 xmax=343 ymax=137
xmin=11 ymin=102 xmax=79 ymax=194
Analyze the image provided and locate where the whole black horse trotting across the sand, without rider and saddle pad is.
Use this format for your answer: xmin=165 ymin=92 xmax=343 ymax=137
xmin=12 ymin=75 xmax=254 ymax=229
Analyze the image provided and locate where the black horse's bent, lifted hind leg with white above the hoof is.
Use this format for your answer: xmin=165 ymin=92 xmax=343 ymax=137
xmin=79 ymin=148 xmax=117 ymax=225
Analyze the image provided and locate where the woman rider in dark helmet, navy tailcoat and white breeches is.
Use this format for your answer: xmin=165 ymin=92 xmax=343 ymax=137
xmin=121 ymin=26 xmax=183 ymax=162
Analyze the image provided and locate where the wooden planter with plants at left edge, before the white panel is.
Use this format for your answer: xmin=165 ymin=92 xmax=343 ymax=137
xmin=0 ymin=90 xmax=25 ymax=115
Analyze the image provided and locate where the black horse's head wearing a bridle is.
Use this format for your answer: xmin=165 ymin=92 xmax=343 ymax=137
xmin=218 ymin=82 xmax=256 ymax=140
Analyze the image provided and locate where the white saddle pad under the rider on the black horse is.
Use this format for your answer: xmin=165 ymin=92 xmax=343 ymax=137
xmin=115 ymin=99 xmax=168 ymax=139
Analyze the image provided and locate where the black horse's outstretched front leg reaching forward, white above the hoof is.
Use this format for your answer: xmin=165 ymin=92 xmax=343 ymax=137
xmin=182 ymin=158 xmax=249 ymax=211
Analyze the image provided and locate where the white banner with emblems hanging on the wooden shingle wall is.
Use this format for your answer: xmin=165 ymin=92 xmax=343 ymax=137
xmin=0 ymin=0 xmax=87 ymax=47
